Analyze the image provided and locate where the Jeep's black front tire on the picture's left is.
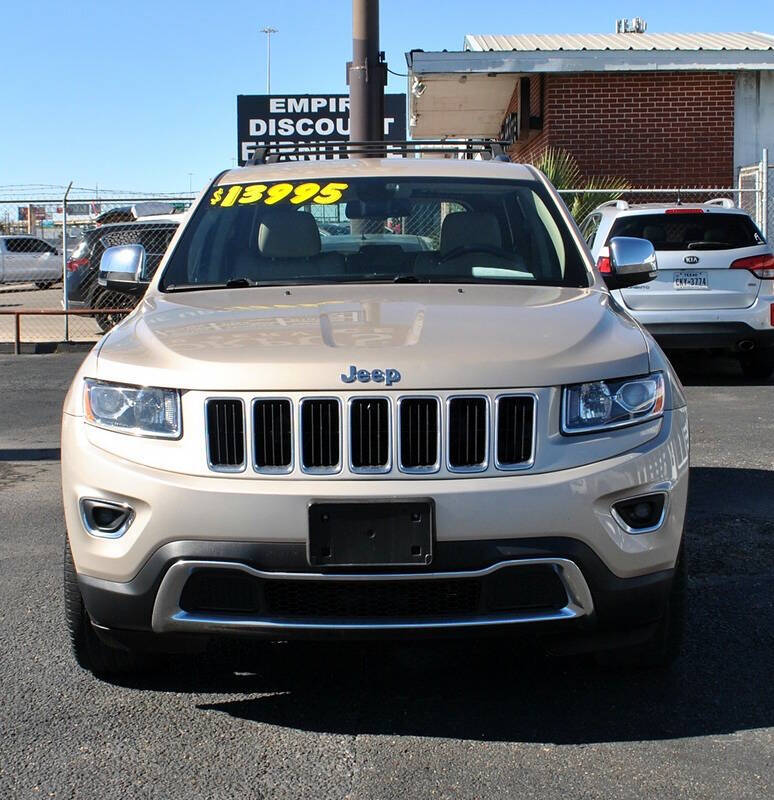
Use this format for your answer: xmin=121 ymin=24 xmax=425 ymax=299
xmin=64 ymin=536 xmax=142 ymax=675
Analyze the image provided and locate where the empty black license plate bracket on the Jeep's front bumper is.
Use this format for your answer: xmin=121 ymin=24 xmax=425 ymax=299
xmin=307 ymin=500 xmax=435 ymax=567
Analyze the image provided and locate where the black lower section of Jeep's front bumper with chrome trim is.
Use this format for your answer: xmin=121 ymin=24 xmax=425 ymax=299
xmin=78 ymin=537 xmax=674 ymax=640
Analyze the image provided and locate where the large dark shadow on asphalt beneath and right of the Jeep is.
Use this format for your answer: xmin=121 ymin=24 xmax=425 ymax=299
xmin=116 ymin=468 xmax=774 ymax=744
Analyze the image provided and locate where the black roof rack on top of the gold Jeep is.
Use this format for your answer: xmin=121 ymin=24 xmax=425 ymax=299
xmin=245 ymin=139 xmax=512 ymax=166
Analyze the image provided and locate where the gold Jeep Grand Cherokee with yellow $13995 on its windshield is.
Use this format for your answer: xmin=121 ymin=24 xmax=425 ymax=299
xmin=62 ymin=139 xmax=688 ymax=673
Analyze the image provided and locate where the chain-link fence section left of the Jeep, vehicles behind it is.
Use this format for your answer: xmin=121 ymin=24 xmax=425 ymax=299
xmin=0 ymin=191 xmax=192 ymax=347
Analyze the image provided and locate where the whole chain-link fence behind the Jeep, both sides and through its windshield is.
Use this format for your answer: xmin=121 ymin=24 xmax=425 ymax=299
xmin=0 ymin=180 xmax=774 ymax=347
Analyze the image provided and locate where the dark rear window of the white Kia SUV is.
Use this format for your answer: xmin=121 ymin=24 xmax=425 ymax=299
xmin=608 ymin=209 xmax=764 ymax=251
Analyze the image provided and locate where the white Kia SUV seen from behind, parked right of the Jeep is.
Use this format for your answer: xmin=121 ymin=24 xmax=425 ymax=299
xmin=581 ymin=199 xmax=774 ymax=379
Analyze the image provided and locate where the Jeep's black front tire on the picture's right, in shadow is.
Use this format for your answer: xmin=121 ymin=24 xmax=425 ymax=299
xmin=596 ymin=547 xmax=688 ymax=668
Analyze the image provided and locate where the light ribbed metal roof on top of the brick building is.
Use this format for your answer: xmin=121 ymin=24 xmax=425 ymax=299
xmin=464 ymin=31 xmax=774 ymax=52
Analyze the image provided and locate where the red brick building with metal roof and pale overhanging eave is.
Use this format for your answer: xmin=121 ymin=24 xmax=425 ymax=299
xmin=407 ymin=32 xmax=774 ymax=187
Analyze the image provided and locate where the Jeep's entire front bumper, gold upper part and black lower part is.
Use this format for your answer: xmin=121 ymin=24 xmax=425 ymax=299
xmin=62 ymin=409 xmax=688 ymax=638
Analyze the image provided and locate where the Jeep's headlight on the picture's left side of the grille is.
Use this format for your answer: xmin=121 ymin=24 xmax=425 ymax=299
xmin=83 ymin=380 xmax=181 ymax=439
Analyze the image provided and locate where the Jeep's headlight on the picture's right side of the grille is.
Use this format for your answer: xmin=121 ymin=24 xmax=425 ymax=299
xmin=562 ymin=372 xmax=664 ymax=433
